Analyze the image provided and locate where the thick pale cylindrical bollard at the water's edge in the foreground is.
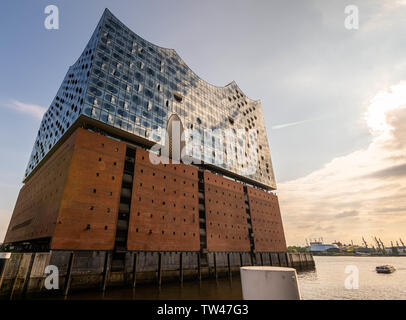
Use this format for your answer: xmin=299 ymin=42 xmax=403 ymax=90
xmin=240 ymin=266 xmax=300 ymax=300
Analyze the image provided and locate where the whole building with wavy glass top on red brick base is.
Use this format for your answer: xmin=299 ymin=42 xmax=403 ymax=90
xmin=4 ymin=9 xmax=286 ymax=281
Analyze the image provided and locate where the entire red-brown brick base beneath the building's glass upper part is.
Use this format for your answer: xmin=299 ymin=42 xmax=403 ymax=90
xmin=4 ymin=128 xmax=286 ymax=255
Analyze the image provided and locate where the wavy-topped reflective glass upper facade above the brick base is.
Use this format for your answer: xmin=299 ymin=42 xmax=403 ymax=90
xmin=26 ymin=9 xmax=276 ymax=188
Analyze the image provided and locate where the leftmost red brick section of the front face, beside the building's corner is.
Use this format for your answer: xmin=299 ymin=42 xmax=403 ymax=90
xmin=51 ymin=129 xmax=126 ymax=250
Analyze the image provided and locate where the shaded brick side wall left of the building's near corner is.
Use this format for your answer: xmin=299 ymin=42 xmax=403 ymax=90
xmin=4 ymin=134 xmax=76 ymax=243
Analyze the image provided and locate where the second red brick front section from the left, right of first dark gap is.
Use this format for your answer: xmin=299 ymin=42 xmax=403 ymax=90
xmin=127 ymin=148 xmax=200 ymax=251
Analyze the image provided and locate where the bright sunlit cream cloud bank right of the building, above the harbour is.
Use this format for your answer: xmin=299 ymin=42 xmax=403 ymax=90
xmin=278 ymin=82 xmax=406 ymax=244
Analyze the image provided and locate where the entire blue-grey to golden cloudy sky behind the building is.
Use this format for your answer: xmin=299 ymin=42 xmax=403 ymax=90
xmin=0 ymin=0 xmax=406 ymax=245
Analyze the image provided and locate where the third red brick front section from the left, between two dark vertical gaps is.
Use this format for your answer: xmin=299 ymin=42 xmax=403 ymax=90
xmin=204 ymin=171 xmax=250 ymax=252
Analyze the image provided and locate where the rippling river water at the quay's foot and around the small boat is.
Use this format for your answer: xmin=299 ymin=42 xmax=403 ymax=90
xmin=68 ymin=257 xmax=406 ymax=300
